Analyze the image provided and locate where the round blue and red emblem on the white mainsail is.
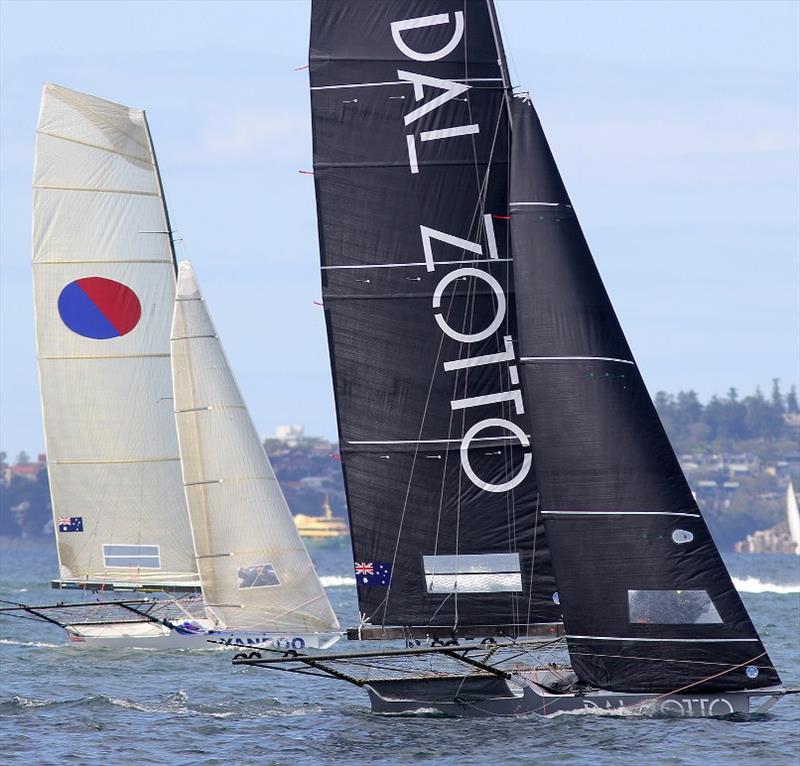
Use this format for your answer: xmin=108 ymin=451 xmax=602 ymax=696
xmin=58 ymin=277 xmax=142 ymax=340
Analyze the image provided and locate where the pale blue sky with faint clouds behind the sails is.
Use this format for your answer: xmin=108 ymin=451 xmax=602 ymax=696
xmin=0 ymin=0 xmax=800 ymax=455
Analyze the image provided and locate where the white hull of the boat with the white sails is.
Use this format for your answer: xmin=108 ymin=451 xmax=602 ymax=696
xmin=64 ymin=621 xmax=341 ymax=651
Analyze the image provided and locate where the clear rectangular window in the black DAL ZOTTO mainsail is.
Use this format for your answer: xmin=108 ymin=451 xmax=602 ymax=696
xmin=422 ymin=553 xmax=522 ymax=593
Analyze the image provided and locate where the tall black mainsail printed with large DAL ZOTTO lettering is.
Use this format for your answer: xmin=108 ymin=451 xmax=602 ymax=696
xmin=310 ymin=0 xmax=560 ymax=637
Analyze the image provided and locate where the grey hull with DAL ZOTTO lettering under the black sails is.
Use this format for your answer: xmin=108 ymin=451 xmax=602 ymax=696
xmin=365 ymin=671 xmax=785 ymax=718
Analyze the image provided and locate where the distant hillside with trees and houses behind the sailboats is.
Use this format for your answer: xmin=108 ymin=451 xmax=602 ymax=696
xmin=0 ymin=380 xmax=800 ymax=550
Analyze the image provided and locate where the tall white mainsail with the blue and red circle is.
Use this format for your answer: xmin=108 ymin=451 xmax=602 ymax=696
xmin=33 ymin=84 xmax=197 ymax=586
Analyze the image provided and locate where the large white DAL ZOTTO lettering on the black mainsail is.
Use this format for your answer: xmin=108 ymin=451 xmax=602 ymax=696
xmin=391 ymin=11 xmax=533 ymax=492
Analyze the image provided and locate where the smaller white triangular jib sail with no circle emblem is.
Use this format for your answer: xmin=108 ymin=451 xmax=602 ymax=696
xmin=172 ymin=261 xmax=339 ymax=631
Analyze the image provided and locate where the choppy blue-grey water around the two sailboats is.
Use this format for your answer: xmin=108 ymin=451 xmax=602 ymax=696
xmin=0 ymin=543 xmax=800 ymax=766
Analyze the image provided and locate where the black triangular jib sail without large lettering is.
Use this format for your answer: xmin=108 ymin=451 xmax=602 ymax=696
xmin=509 ymin=98 xmax=779 ymax=693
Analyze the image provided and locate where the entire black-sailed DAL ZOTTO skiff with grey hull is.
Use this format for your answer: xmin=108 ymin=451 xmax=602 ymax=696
xmin=236 ymin=0 xmax=788 ymax=716
